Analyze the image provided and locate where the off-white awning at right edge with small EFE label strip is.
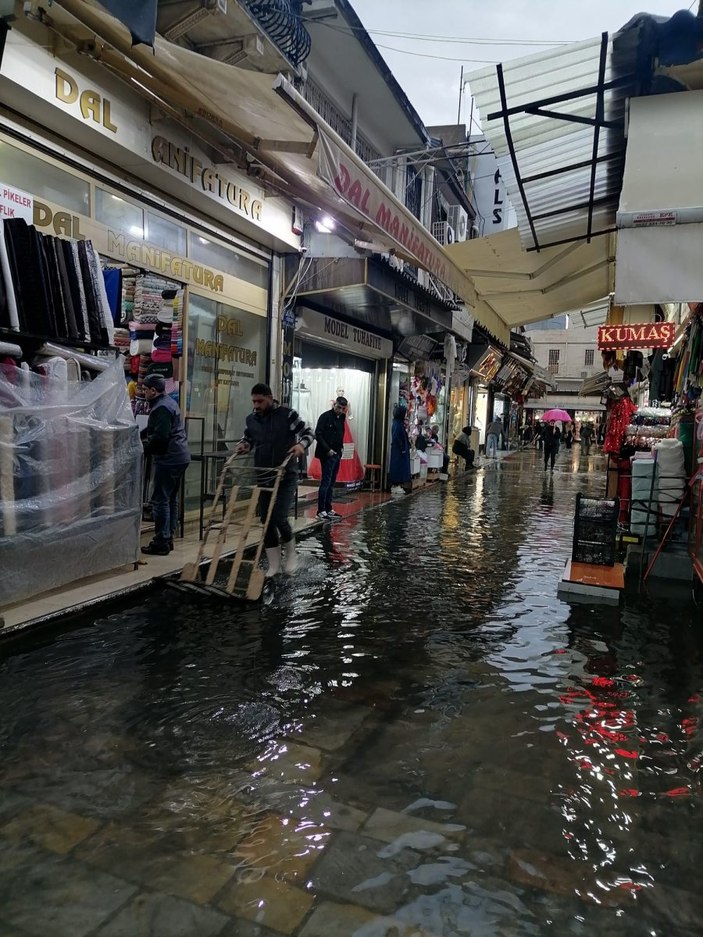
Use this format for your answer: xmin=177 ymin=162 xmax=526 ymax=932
xmin=615 ymin=91 xmax=703 ymax=304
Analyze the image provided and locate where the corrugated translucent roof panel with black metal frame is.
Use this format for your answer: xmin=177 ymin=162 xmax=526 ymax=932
xmin=469 ymin=29 xmax=639 ymax=250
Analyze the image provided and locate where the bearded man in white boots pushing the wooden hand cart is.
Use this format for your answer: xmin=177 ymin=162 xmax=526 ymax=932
xmin=235 ymin=384 xmax=313 ymax=578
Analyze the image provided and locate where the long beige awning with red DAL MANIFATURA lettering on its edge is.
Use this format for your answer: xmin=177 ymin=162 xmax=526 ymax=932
xmin=52 ymin=0 xmax=508 ymax=344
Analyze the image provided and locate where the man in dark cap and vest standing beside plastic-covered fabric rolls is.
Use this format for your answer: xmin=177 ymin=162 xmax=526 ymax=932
xmin=142 ymin=374 xmax=190 ymax=556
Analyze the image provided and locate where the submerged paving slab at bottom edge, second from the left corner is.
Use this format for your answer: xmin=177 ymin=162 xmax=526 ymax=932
xmin=95 ymin=894 xmax=229 ymax=937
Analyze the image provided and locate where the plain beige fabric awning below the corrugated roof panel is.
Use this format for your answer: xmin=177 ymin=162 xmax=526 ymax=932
xmin=446 ymin=228 xmax=615 ymax=328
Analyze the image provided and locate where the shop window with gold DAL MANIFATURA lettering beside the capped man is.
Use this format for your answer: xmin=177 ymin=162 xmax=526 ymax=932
xmin=186 ymin=293 xmax=267 ymax=508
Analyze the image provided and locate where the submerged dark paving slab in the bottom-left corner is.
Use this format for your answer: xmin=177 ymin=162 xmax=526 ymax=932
xmin=2 ymin=860 xmax=136 ymax=937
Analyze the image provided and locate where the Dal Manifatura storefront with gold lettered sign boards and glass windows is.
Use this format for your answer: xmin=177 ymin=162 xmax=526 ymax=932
xmin=0 ymin=21 xmax=299 ymax=505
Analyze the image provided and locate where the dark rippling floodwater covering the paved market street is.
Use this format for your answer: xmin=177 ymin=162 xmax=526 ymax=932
xmin=0 ymin=449 xmax=703 ymax=937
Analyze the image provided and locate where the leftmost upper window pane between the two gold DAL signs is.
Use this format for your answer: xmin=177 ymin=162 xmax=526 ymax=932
xmin=0 ymin=140 xmax=90 ymax=215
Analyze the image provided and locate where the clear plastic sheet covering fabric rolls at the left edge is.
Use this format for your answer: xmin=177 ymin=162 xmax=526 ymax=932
xmin=0 ymin=359 xmax=143 ymax=606
